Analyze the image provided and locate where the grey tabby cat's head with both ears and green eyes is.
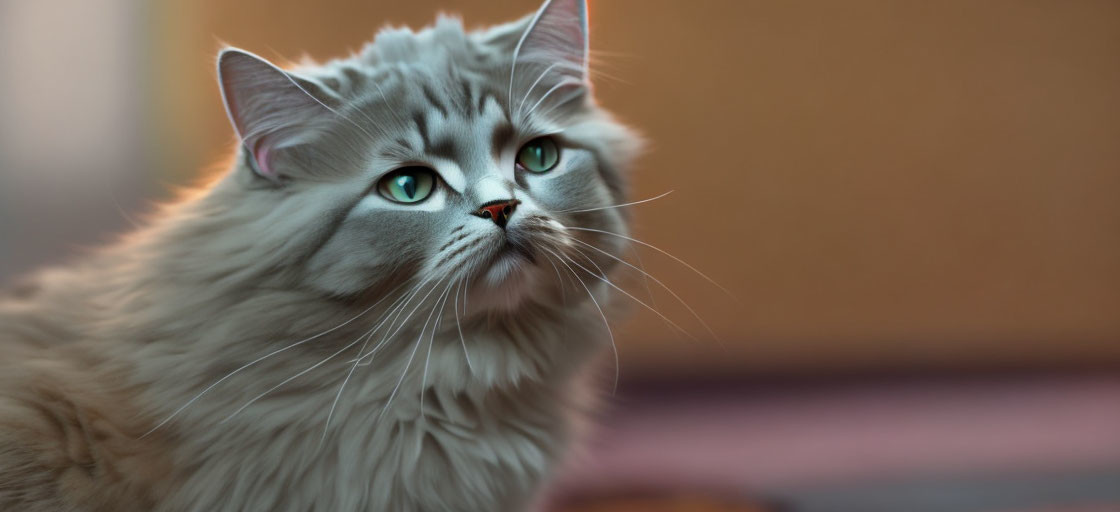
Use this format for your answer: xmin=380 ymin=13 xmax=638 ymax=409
xmin=212 ymin=0 xmax=636 ymax=310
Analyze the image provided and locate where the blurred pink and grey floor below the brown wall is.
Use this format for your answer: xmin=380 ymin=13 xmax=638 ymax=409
xmin=551 ymin=373 xmax=1120 ymax=512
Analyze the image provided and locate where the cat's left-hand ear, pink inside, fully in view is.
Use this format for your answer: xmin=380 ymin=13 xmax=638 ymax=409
xmin=217 ymin=48 xmax=334 ymax=180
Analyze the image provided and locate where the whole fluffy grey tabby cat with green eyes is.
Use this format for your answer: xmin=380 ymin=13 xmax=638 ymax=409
xmin=0 ymin=0 xmax=640 ymax=512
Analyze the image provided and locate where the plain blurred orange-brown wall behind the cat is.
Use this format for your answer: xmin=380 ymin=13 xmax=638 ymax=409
xmin=150 ymin=0 xmax=1120 ymax=372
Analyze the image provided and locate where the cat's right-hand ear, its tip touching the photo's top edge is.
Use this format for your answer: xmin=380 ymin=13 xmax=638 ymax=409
xmin=513 ymin=0 xmax=589 ymax=96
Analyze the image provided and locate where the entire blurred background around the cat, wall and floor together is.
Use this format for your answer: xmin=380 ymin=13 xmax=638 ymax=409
xmin=0 ymin=0 xmax=1120 ymax=512
